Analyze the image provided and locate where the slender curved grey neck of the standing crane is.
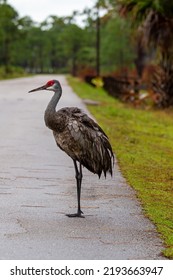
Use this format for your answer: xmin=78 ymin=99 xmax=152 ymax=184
xmin=44 ymin=87 xmax=62 ymax=128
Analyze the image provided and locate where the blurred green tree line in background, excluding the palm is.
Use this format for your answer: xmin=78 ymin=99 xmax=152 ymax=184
xmin=0 ymin=1 xmax=134 ymax=75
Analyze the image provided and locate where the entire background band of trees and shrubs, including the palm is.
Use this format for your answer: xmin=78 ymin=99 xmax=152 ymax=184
xmin=0 ymin=0 xmax=173 ymax=107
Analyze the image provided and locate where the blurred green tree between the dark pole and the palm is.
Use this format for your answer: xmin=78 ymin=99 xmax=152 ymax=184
xmin=101 ymin=15 xmax=135 ymax=73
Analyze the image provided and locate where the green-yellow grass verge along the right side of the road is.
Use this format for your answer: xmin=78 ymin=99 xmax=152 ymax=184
xmin=68 ymin=77 xmax=173 ymax=259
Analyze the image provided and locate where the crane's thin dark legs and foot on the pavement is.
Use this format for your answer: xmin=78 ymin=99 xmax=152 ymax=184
xmin=67 ymin=160 xmax=84 ymax=218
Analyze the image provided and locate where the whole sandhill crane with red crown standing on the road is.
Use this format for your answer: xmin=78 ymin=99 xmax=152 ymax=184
xmin=29 ymin=80 xmax=114 ymax=217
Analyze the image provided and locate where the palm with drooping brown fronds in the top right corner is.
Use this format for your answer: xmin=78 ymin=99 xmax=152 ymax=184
xmin=117 ymin=0 xmax=173 ymax=107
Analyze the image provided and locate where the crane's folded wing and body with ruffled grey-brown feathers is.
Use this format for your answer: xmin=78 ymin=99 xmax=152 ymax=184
xmin=54 ymin=108 xmax=114 ymax=177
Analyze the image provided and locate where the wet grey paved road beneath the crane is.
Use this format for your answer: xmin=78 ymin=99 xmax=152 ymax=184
xmin=0 ymin=75 xmax=166 ymax=260
